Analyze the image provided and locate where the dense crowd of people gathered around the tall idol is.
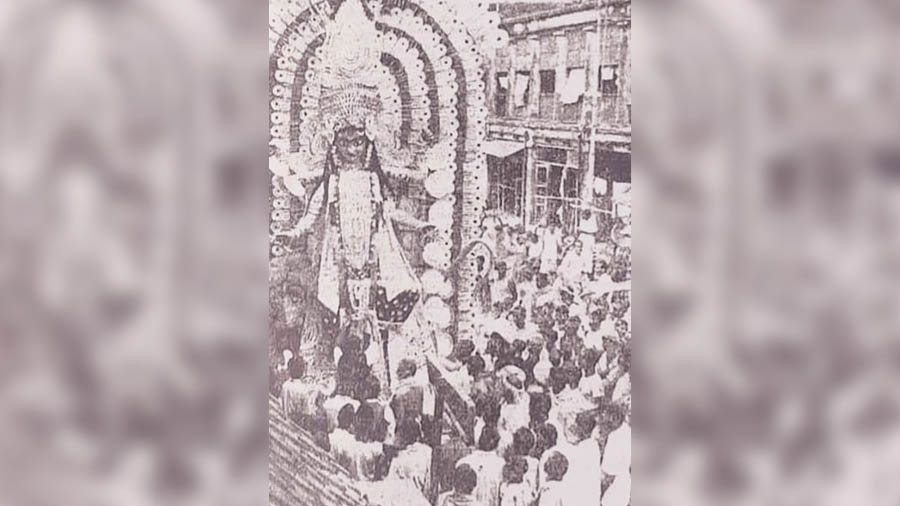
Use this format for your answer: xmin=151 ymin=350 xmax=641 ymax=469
xmin=274 ymin=208 xmax=631 ymax=506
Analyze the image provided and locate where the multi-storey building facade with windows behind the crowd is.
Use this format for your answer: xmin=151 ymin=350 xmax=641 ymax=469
xmin=485 ymin=0 xmax=631 ymax=230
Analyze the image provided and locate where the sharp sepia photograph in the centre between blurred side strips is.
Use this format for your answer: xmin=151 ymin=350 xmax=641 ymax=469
xmin=269 ymin=0 xmax=631 ymax=506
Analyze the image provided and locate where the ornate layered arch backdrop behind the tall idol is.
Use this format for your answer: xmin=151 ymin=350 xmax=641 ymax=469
xmin=269 ymin=0 xmax=508 ymax=344
